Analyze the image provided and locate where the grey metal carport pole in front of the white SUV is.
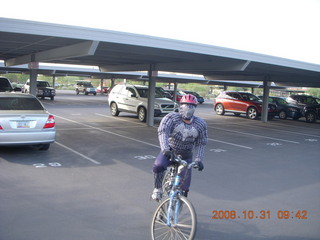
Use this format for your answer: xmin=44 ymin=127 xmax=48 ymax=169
xmin=147 ymin=65 xmax=158 ymax=127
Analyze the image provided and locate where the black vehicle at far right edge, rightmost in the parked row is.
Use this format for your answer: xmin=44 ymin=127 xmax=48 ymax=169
xmin=287 ymin=95 xmax=320 ymax=123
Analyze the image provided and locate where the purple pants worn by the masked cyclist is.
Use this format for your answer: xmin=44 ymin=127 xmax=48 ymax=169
xmin=153 ymin=152 xmax=192 ymax=191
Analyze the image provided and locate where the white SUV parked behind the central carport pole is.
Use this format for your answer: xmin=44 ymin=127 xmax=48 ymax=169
xmin=108 ymin=84 xmax=178 ymax=122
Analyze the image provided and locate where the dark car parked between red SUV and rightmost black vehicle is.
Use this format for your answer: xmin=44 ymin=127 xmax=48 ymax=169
xmin=259 ymin=96 xmax=302 ymax=120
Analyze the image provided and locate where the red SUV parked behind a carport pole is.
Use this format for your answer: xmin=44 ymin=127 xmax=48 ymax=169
xmin=214 ymin=91 xmax=277 ymax=119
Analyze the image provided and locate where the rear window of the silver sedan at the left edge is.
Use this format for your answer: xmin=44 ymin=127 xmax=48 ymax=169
xmin=0 ymin=97 xmax=43 ymax=110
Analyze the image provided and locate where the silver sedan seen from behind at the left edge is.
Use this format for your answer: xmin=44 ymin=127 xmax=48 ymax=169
xmin=0 ymin=93 xmax=56 ymax=150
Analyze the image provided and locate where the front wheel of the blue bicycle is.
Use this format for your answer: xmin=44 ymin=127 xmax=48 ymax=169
xmin=151 ymin=196 xmax=197 ymax=240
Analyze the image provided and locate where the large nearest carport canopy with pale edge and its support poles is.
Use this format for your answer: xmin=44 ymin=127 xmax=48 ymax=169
xmin=0 ymin=18 xmax=320 ymax=126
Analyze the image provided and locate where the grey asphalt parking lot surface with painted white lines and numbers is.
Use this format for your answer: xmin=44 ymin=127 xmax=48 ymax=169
xmin=0 ymin=92 xmax=320 ymax=240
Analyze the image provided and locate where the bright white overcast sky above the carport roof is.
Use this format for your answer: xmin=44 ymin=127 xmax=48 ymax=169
xmin=0 ymin=0 xmax=320 ymax=64
